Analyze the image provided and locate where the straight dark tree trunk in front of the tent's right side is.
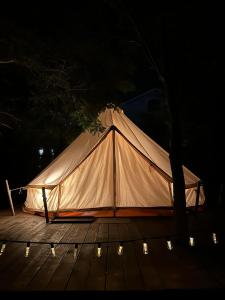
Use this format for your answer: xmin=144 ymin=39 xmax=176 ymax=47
xmin=162 ymin=18 xmax=188 ymax=241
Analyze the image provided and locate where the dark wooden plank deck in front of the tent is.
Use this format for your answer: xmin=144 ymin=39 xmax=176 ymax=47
xmin=0 ymin=207 xmax=225 ymax=294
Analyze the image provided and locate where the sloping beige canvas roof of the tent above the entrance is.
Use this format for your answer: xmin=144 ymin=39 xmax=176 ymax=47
xmin=28 ymin=108 xmax=199 ymax=187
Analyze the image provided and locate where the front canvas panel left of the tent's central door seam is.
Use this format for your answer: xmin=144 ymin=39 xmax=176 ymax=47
xmin=59 ymin=132 xmax=113 ymax=210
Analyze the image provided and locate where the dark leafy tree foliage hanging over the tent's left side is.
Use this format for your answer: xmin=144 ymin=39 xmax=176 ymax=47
xmin=0 ymin=1 xmax=158 ymax=148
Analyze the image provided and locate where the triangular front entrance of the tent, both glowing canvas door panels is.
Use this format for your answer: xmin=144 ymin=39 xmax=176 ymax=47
xmin=54 ymin=126 xmax=171 ymax=216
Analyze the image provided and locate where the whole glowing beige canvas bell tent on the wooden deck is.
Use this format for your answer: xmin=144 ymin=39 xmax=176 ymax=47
xmin=25 ymin=108 xmax=204 ymax=215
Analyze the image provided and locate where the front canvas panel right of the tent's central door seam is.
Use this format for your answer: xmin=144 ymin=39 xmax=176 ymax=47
xmin=115 ymin=132 xmax=171 ymax=207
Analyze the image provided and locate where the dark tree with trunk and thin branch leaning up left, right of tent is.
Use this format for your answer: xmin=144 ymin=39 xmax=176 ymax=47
xmin=114 ymin=2 xmax=188 ymax=240
